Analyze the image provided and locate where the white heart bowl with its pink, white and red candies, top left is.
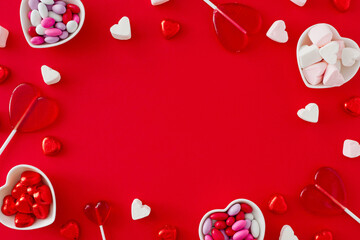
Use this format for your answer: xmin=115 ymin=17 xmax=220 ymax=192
xmin=20 ymin=0 xmax=85 ymax=48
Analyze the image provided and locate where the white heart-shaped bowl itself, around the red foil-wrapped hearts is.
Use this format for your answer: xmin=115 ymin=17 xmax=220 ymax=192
xmin=0 ymin=165 xmax=56 ymax=230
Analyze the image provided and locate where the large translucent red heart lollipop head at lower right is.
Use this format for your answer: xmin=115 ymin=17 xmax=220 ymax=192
xmin=300 ymin=167 xmax=346 ymax=215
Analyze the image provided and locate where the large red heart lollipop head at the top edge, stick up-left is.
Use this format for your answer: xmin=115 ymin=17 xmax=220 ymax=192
xmin=213 ymin=3 xmax=262 ymax=52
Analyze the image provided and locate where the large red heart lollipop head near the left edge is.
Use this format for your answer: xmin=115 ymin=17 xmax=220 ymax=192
xmin=9 ymin=83 xmax=59 ymax=132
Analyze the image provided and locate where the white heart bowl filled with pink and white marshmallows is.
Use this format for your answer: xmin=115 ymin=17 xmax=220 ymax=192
xmin=296 ymin=23 xmax=360 ymax=89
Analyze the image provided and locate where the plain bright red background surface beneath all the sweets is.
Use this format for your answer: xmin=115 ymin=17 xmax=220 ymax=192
xmin=0 ymin=0 xmax=360 ymax=240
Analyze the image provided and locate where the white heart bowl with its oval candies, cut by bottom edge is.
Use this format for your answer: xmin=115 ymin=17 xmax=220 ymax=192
xmin=199 ymin=199 xmax=265 ymax=240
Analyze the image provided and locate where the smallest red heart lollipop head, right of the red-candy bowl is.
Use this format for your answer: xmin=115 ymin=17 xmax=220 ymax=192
xmin=84 ymin=201 xmax=111 ymax=226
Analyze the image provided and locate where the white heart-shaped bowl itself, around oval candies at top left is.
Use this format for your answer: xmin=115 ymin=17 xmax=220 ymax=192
xmin=20 ymin=0 xmax=85 ymax=48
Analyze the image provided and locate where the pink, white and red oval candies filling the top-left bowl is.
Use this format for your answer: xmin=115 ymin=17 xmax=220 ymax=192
xmin=28 ymin=0 xmax=80 ymax=45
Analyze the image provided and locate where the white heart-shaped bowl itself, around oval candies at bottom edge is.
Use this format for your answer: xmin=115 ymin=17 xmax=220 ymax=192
xmin=199 ymin=199 xmax=265 ymax=240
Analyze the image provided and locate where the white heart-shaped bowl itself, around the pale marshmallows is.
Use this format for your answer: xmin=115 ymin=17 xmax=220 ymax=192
xmin=296 ymin=23 xmax=360 ymax=89
